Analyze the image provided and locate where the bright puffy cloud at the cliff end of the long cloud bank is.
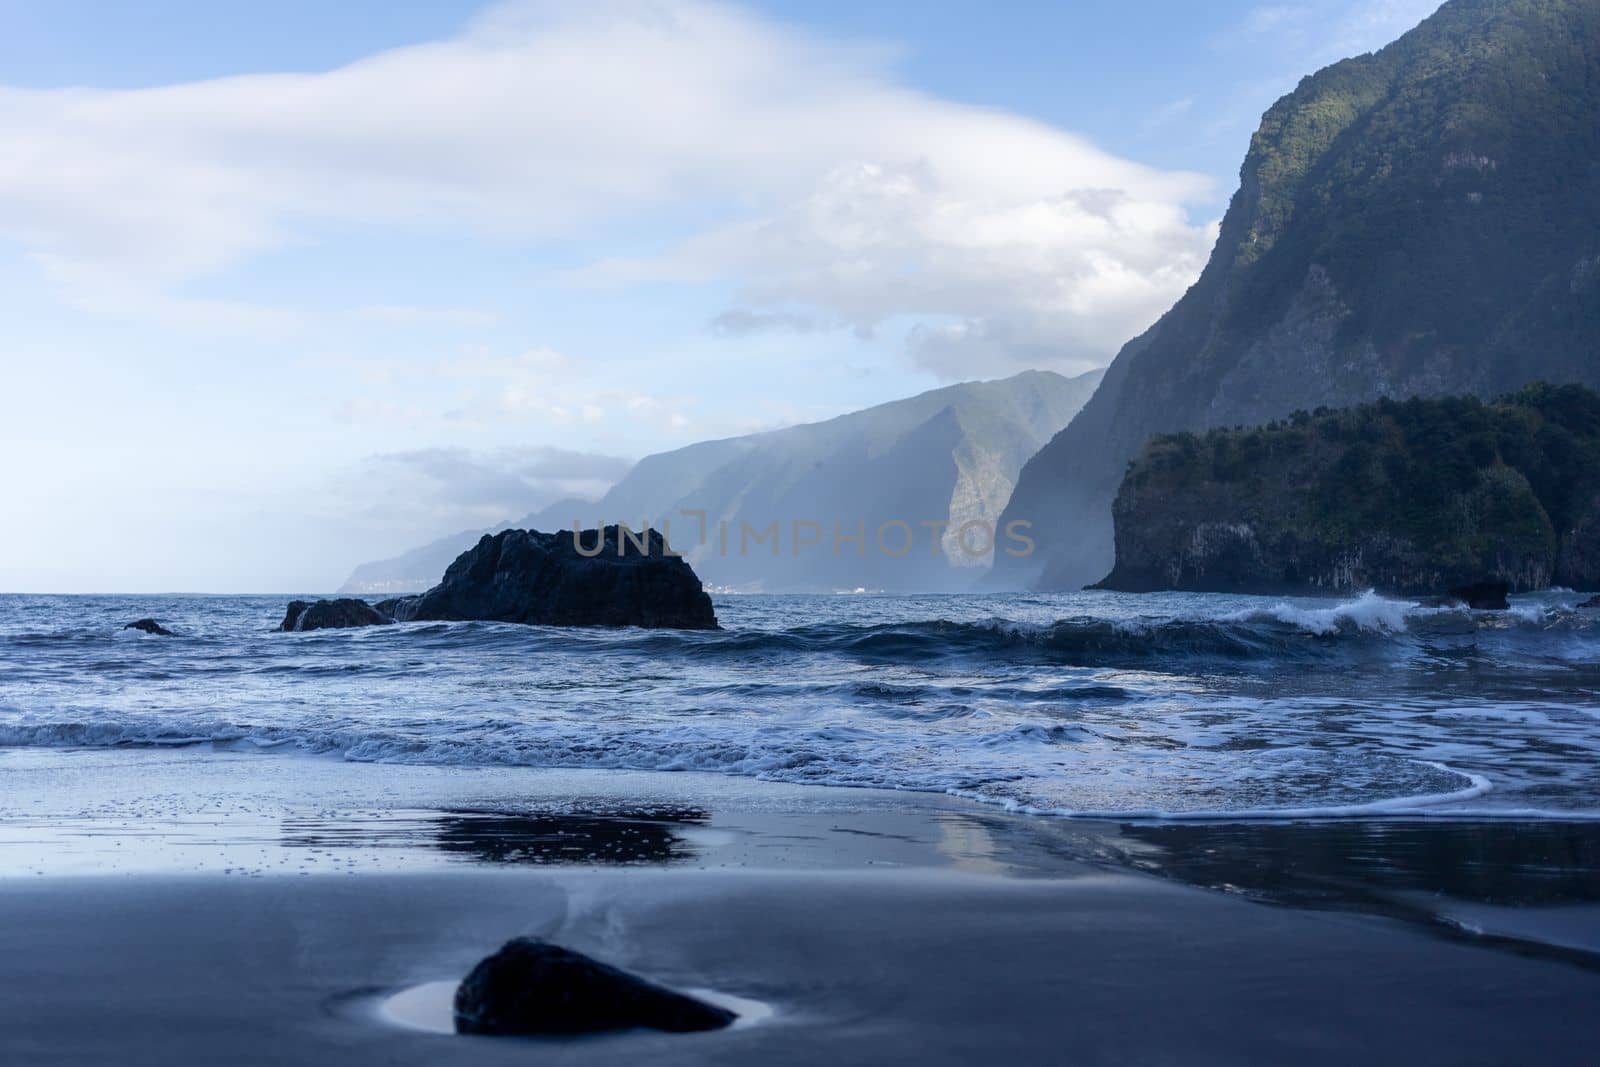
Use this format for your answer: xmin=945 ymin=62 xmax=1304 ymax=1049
xmin=678 ymin=167 xmax=1216 ymax=379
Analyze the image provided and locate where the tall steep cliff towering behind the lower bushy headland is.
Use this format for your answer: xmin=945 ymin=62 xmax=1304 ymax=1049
xmin=995 ymin=0 xmax=1600 ymax=589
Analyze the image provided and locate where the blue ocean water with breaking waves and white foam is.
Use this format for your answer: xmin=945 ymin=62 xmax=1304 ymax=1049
xmin=0 ymin=592 xmax=1600 ymax=819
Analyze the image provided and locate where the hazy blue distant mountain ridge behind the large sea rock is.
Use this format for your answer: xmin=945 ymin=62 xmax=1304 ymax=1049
xmin=341 ymin=371 xmax=1101 ymax=593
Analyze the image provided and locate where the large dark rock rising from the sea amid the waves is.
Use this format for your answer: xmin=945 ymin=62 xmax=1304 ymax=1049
xmin=379 ymin=526 xmax=717 ymax=630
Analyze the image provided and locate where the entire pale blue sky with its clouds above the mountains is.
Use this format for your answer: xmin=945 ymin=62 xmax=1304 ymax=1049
xmin=0 ymin=0 xmax=1432 ymax=592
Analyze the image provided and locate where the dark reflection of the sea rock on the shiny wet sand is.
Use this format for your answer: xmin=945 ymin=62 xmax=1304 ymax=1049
xmin=282 ymin=808 xmax=710 ymax=864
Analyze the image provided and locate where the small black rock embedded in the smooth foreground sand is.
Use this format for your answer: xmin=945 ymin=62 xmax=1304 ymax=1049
xmin=454 ymin=937 xmax=738 ymax=1037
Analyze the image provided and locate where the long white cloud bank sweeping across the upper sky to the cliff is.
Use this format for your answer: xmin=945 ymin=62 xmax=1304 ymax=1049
xmin=0 ymin=0 xmax=1210 ymax=375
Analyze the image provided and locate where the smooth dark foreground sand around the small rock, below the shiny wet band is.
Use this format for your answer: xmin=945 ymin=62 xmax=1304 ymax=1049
xmin=0 ymin=870 xmax=1600 ymax=1064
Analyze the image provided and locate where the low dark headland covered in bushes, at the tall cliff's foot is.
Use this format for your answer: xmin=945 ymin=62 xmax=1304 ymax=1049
xmin=1102 ymin=386 xmax=1600 ymax=593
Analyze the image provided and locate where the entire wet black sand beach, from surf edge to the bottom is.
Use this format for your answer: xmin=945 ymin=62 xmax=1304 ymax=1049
xmin=9 ymin=752 xmax=1600 ymax=1064
